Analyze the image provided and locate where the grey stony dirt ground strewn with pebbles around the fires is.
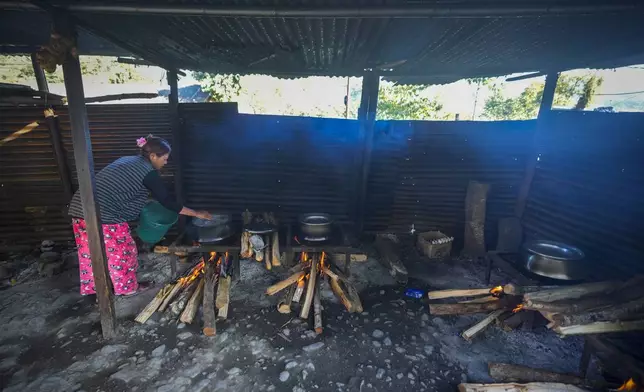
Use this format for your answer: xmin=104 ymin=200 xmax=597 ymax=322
xmin=0 ymin=240 xmax=582 ymax=392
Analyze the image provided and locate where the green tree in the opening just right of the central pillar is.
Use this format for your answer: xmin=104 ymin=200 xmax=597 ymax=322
xmin=376 ymin=83 xmax=449 ymax=120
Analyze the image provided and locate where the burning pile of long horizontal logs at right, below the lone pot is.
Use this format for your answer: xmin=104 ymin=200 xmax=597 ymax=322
xmin=428 ymin=276 xmax=644 ymax=340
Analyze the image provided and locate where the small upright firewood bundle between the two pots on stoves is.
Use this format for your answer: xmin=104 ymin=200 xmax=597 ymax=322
xmin=240 ymin=210 xmax=282 ymax=270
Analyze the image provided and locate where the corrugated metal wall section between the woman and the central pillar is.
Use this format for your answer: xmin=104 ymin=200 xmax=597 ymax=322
xmin=181 ymin=104 xmax=360 ymax=223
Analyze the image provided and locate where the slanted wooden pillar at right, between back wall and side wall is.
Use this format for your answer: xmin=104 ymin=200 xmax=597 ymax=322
xmin=514 ymin=73 xmax=559 ymax=219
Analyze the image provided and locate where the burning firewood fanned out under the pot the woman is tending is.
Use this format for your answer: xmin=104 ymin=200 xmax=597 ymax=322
xmin=135 ymin=252 xmax=232 ymax=336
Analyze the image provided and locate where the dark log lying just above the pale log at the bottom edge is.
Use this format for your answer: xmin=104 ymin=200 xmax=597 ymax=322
xmin=488 ymin=362 xmax=587 ymax=385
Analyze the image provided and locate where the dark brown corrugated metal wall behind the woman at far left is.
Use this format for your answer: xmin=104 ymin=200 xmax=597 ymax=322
xmin=0 ymin=104 xmax=174 ymax=245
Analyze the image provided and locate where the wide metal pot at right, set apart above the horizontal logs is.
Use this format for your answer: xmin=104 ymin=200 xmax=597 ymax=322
xmin=521 ymin=240 xmax=588 ymax=280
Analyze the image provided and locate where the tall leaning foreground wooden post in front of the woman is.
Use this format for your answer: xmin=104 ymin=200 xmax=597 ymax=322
xmin=56 ymin=19 xmax=116 ymax=339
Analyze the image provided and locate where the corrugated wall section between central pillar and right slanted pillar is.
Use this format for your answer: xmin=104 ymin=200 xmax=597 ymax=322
xmin=367 ymin=121 xmax=535 ymax=248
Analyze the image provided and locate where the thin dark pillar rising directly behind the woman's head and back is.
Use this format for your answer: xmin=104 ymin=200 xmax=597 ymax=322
xmin=168 ymin=69 xmax=186 ymax=231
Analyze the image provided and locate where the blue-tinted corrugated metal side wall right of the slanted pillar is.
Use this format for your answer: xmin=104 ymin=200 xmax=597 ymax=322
xmin=524 ymin=111 xmax=644 ymax=277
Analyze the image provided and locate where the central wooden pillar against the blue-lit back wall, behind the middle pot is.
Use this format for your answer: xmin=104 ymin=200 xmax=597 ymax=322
xmin=356 ymin=71 xmax=380 ymax=232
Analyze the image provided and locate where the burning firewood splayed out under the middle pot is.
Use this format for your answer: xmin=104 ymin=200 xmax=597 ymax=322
xmin=266 ymin=252 xmax=363 ymax=334
